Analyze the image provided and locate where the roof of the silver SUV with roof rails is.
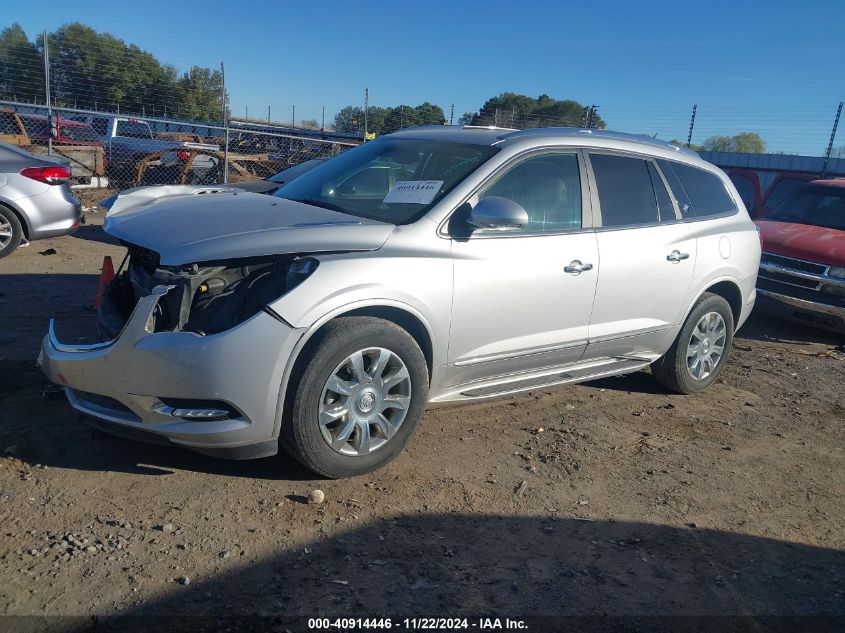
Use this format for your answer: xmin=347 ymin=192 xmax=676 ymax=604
xmin=390 ymin=125 xmax=698 ymax=158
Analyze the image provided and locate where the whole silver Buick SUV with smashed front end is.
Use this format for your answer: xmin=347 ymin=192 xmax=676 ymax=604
xmin=40 ymin=127 xmax=760 ymax=477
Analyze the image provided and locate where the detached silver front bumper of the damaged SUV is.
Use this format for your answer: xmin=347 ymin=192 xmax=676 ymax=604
xmin=38 ymin=286 xmax=304 ymax=458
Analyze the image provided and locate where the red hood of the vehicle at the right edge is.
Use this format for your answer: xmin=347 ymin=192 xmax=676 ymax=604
xmin=757 ymin=220 xmax=845 ymax=266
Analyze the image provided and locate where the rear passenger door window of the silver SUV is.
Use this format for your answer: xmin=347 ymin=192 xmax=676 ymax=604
xmin=590 ymin=153 xmax=660 ymax=227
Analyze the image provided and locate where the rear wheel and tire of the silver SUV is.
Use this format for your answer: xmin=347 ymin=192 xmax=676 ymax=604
xmin=651 ymin=292 xmax=734 ymax=394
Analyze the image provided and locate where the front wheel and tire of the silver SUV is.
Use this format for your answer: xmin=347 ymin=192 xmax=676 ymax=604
xmin=281 ymin=317 xmax=428 ymax=479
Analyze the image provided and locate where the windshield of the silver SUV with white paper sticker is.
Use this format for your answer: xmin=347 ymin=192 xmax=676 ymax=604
xmin=273 ymin=137 xmax=497 ymax=224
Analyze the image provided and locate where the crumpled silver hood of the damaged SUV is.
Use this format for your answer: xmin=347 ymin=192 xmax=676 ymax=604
xmin=103 ymin=186 xmax=394 ymax=266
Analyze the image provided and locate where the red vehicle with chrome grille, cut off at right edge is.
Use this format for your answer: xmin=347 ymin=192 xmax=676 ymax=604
xmin=757 ymin=179 xmax=845 ymax=333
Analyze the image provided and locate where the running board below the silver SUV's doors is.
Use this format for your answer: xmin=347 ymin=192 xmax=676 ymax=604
xmin=431 ymin=358 xmax=652 ymax=404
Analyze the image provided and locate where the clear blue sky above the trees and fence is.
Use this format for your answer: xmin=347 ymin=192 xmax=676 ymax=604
xmin=0 ymin=0 xmax=845 ymax=154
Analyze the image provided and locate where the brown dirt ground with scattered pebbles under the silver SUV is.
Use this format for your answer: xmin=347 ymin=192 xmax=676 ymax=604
xmin=0 ymin=211 xmax=845 ymax=630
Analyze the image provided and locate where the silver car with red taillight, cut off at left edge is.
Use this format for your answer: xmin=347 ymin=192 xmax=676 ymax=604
xmin=0 ymin=142 xmax=81 ymax=258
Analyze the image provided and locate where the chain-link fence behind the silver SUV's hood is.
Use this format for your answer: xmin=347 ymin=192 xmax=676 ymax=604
xmin=0 ymin=102 xmax=357 ymax=190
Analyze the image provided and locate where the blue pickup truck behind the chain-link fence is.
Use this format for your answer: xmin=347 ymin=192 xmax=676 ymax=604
xmin=68 ymin=115 xmax=220 ymax=188
